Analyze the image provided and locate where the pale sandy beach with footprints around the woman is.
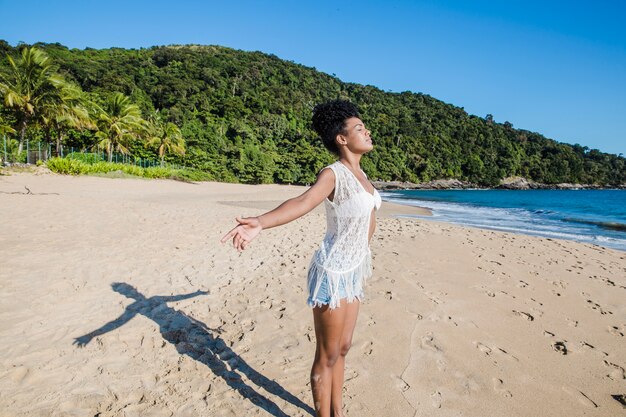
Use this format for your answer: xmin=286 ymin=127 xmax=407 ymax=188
xmin=0 ymin=174 xmax=626 ymax=417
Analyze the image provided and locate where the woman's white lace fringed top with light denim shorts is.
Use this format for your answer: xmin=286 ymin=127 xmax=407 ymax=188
xmin=308 ymin=161 xmax=381 ymax=309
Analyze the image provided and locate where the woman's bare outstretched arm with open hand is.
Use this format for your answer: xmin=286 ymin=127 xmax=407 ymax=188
xmin=221 ymin=169 xmax=335 ymax=252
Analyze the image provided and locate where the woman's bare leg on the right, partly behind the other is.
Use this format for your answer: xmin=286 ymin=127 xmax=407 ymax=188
xmin=330 ymin=300 xmax=360 ymax=417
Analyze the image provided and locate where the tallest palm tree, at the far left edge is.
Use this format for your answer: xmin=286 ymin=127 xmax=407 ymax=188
xmin=0 ymin=46 xmax=63 ymax=153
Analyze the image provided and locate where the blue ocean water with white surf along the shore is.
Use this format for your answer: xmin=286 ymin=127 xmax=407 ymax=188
xmin=381 ymin=190 xmax=626 ymax=251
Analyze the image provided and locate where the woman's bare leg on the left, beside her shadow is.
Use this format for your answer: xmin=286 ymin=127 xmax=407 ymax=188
xmin=311 ymin=302 xmax=348 ymax=417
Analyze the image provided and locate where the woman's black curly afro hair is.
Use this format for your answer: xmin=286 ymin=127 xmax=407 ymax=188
xmin=312 ymin=100 xmax=361 ymax=155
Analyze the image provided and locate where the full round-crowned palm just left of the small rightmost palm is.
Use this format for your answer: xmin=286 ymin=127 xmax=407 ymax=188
xmin=96 ymin=93 xmax=146 ymax=162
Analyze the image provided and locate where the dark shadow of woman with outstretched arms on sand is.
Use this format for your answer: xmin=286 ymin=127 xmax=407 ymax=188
xmin=74 ymin=282 xmax=315 ymax=417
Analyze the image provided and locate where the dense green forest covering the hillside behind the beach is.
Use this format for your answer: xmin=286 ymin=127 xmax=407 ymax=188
xmin=0 ymin=41 xmax=626 ymax=186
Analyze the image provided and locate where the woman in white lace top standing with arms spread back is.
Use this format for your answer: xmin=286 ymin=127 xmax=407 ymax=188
xmin=222 ymin=100 xmax=381 ymax=417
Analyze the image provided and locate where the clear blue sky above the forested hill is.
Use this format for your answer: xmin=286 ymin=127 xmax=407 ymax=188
xmin=0 ymin=0 xmax=626 ymax=154
